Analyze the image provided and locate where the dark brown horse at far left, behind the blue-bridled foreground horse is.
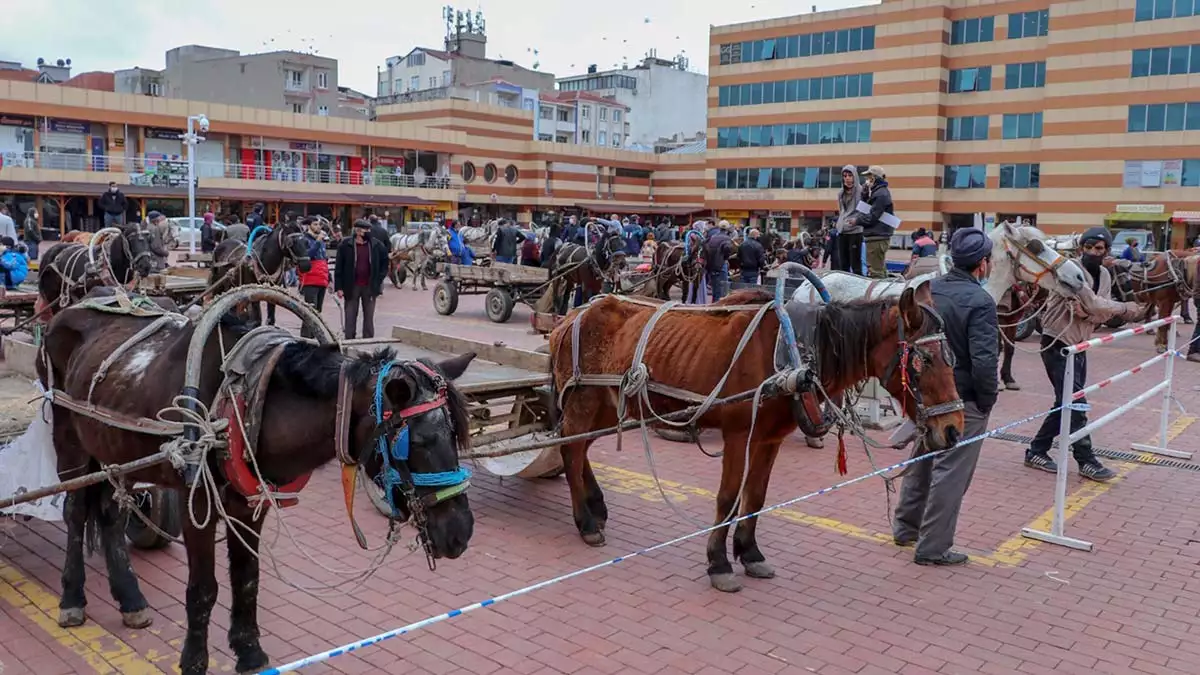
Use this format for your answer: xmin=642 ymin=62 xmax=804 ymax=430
xmin=35 ymin=221 xmax=168 ymax=319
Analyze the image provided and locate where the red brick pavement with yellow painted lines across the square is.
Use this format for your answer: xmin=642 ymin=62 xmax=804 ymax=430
xmin=0 ymin=284 xmax=1200 ymax=675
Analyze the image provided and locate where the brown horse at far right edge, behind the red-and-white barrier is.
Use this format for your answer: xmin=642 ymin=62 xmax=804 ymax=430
xmin=1104 ymin=250 xmax=1200 ymax=353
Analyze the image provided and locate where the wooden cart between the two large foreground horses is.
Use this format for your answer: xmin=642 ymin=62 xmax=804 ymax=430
xmin=352 ymin=325 xmax=563 ymax=515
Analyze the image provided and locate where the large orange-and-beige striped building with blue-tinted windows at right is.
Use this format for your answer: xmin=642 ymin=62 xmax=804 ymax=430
xmin=706 ymin=0 xmax=1200 ymax=245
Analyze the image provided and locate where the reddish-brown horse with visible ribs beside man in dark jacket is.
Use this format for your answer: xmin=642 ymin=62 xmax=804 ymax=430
xmin=550 ymin=283 xmax=964 ymax=592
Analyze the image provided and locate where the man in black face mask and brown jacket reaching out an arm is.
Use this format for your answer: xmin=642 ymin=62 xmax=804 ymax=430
xmin=1025 ymin=227 xmax=1146 ymax=482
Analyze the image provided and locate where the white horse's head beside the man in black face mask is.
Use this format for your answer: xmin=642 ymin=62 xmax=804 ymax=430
xmin=986 ymin=221 xmax=1087 ymax=301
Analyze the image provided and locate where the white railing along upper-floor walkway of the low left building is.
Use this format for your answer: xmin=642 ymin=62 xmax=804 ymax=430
xmin=0 ymin=153 xmax=462 ymax=190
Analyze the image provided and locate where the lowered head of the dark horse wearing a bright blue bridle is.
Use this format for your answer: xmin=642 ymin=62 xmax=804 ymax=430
xmin=341 ymin=350 xmax=475 ymax=560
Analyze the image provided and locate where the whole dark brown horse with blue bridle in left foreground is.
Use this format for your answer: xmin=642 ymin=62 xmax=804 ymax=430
xmin=37 ymin=288 xmax=474 ymax=675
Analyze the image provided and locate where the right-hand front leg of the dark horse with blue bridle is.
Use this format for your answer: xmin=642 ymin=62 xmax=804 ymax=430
xmin=226 ymin=497 xmax=270 ymax=673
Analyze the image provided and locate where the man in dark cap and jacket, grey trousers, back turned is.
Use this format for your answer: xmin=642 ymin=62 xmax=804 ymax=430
xmin=893 ymin=227 xmax=1000 ymax=566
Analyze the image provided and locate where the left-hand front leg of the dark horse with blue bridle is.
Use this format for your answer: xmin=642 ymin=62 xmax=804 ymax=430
xmin=179 ymin=491 xmax=217 ymax=675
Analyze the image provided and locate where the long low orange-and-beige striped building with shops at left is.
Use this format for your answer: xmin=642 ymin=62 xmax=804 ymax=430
xmin=0 ymin=79 xmax=704 ymax=231
